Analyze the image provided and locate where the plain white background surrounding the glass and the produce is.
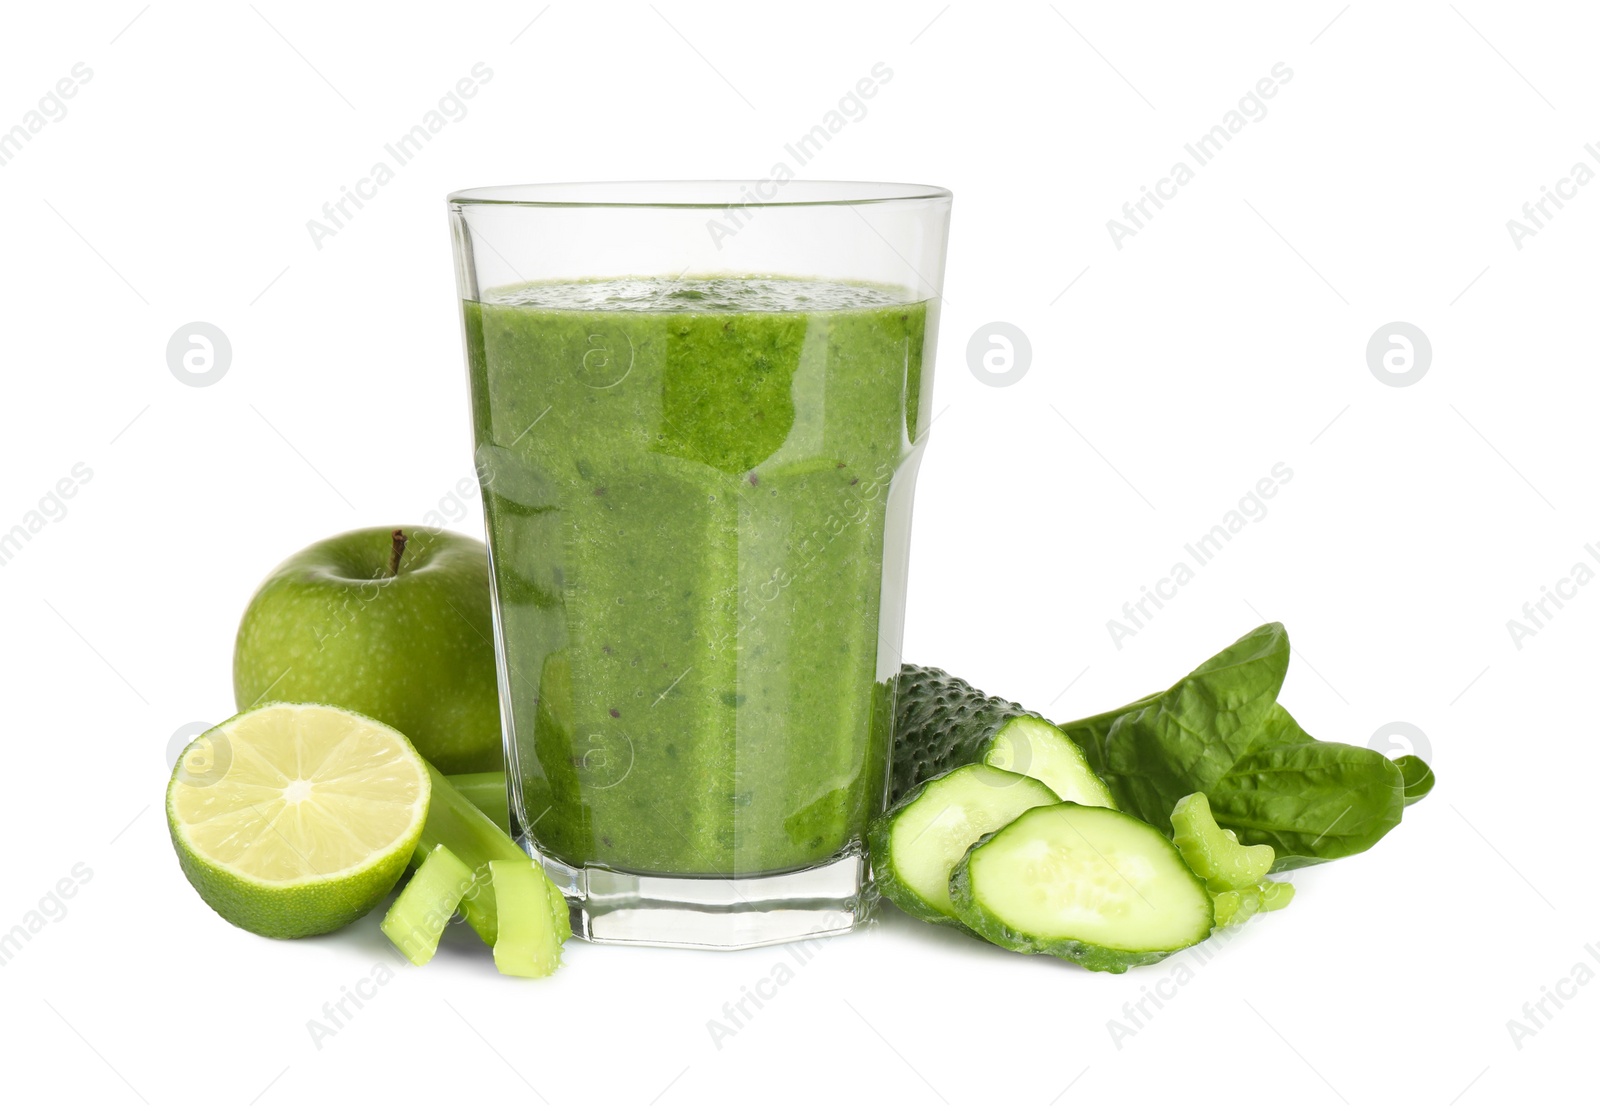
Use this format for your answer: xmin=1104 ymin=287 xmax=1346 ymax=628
xmin=0 ymin=0 xmax=1600 ymax=1109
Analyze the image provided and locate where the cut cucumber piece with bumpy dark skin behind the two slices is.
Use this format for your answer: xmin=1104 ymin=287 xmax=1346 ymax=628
xmin=890 ymin=664 xmax=1112 ymax=807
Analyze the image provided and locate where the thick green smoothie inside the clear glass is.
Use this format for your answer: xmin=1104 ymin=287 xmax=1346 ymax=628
xmin=464 ymin=277 xmax=930 ymax=876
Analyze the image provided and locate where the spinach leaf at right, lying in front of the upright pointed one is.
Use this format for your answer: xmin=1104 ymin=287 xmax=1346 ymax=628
xmin=1206 ymin=706 xmax=1405 ymax=871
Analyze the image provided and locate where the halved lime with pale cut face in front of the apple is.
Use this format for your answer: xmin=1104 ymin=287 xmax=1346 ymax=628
xmin=166 ymin=703 xmax=429 ymax=938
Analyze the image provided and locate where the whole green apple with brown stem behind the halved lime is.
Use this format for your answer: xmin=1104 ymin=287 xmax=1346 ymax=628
xmin=234 ymin=528 xmax=502 ymax=775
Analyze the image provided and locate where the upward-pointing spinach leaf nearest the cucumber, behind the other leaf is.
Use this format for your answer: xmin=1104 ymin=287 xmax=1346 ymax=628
xmin=1101 ymin=623 xmax=1290 ymax=832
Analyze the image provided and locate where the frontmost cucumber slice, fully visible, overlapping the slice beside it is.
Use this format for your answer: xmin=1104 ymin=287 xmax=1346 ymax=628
xmin=950 ymin=802 xmax=1214 ymax=972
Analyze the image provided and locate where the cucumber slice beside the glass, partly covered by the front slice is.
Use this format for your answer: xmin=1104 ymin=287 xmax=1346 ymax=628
xmin=867 ymin=764 xmax=1059 ymax=925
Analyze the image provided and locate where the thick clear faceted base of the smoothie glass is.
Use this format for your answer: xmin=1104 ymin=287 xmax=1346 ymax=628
xmin=522 ymin=837 xmax=874 ymax=949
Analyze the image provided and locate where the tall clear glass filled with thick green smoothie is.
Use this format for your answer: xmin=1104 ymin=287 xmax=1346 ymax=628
xmin=450 ymin=178 xmax=950 ymax=949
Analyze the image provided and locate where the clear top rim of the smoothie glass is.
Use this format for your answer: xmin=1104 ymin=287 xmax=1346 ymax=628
xmin=446 ymin=178 xmax=950 ymax=211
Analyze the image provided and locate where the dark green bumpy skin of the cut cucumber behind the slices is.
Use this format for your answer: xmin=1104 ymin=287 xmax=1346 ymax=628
xmin=890 ymin=664 xmax=1030 ymax=807
